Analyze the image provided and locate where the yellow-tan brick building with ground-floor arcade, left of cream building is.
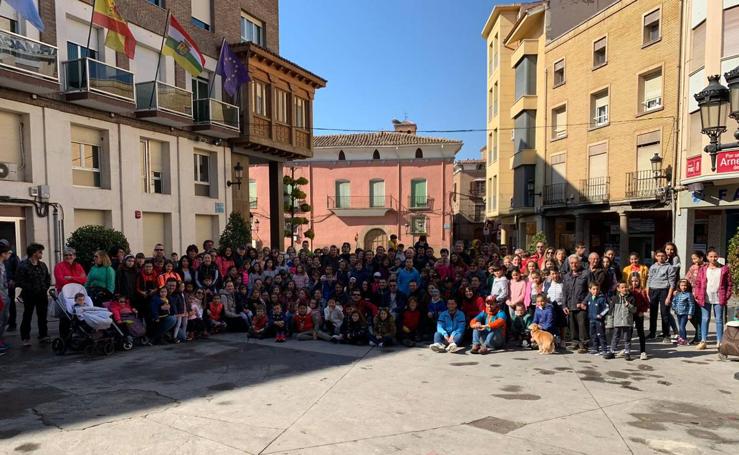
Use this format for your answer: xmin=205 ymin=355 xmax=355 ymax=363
xmin=537 ymin=0 xmax=681 ymax=260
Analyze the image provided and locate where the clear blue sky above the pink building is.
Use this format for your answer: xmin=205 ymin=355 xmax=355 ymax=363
xmin=280 ymin=0 xmax=495 ymax=159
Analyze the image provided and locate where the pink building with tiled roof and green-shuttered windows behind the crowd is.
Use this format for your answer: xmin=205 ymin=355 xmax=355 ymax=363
xmin=249 ymin=120 xmax=462 ymax=251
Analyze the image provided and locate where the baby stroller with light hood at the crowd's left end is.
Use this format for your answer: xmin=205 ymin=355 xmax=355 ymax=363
xmin=51 ymin=283 xmax=123 ymax=356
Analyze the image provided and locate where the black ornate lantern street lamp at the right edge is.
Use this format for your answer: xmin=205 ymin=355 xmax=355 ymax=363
xmin=694 ymin=75 xmax=739 ymax=172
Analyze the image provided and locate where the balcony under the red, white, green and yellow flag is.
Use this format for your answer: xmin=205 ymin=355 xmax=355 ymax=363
xmin=136 ymin=81 xmax=192 ymax=128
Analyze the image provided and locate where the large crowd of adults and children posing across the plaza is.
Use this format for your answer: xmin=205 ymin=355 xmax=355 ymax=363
xmin=0 ymin=237 xmax=737 ymax=360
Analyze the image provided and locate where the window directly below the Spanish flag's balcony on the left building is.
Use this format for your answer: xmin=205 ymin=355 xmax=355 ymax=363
xmin=71 ymin=126 xmax=103 ymax=188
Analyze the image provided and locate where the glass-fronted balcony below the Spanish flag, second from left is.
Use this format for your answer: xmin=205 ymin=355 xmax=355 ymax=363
xmin=62 ymin=57 xmax=136 ymax=114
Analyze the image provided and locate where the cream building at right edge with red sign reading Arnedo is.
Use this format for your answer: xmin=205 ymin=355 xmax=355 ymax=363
xmin=675 ymin=0 xmax=739 ymax=257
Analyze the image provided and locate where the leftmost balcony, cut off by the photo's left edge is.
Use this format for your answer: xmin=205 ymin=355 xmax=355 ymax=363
xmin=0 ymin=30 xmax=59 ymax=95
